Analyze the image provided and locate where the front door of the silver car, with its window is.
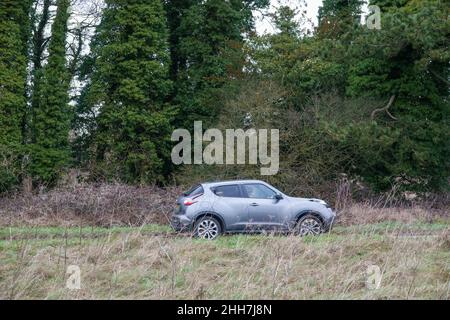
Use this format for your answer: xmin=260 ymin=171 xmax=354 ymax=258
xmin=242 ymin=183 xmax=285 ymax=229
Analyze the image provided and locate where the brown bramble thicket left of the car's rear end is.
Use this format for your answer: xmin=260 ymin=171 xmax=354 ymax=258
xmin=0 ymin=184 xmax=182 ymax=226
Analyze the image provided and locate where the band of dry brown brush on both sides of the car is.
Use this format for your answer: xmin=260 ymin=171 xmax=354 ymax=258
xmin=0 ymin=183 xmax=450 ymax=227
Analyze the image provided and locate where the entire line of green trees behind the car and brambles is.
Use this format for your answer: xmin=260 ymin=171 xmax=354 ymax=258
xmin=0 ymin=0 xmax=450 ymax=196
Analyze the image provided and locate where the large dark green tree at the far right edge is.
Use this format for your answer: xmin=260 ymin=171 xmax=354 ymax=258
xmin=344 ymin=1 xmax=450 ymax=190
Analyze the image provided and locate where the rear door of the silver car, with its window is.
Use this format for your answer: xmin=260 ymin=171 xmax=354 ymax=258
xmin=211 ymin=184 xmax=248 ymax=231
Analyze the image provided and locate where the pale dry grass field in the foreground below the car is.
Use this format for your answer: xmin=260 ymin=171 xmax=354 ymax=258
xmin=0 ymin=219 xmax=450 ymax=299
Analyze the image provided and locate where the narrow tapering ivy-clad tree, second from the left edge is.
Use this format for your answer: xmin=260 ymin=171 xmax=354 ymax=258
xmin=29 ymin=0 xmax=71 ymax=184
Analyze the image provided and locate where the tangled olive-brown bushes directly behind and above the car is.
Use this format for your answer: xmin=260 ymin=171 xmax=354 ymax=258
xmin=177 ymin=77 xmax=354 ymax=197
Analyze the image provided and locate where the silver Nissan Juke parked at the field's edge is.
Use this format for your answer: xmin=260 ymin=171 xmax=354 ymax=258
xmin=171 ymin=180 xmax=336 ymax=240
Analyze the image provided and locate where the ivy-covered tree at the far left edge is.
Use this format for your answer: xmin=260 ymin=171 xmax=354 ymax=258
xmin=0 ymin=0 xmax=30 ymax=192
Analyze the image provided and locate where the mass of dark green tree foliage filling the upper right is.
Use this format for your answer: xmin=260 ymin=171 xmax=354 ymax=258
xmin=249 ymin=1 xmax=450 ymax=191
